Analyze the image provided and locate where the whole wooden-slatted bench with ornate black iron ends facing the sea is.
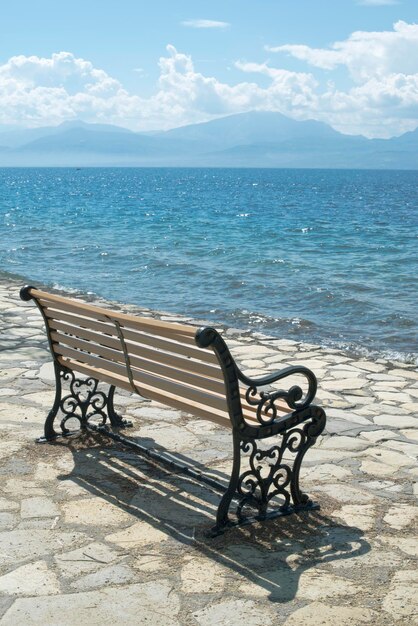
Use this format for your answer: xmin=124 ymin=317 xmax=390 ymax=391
xmin=20 ymin=286 xmax=326 ymax=534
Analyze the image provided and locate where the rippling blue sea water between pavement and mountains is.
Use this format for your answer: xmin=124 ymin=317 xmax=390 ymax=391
xmin=0 ymin=168 xmax=418 ymax=361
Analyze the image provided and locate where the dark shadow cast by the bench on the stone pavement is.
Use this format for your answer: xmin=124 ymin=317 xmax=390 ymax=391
xmin=55 ymin=433 xmax=370 ymax=602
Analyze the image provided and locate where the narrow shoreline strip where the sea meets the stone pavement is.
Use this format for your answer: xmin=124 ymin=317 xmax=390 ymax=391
xmin=0 ymin=269 xmax=418 ymax=368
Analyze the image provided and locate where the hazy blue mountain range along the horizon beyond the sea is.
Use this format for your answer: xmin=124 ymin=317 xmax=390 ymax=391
xmin=0 ymin=111 xmax=418 ymax=169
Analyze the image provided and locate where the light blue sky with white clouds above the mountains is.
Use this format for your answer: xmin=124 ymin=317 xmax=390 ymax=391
xmin=0 ymin=0 xmax=418 ymax=137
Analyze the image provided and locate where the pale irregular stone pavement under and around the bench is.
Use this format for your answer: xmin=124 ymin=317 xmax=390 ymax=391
xmin=0 ymin=280 xmax=418 ymax=626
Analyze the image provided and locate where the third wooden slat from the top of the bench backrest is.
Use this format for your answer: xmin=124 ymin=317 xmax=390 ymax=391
xmin=48 ymin=320 xmax=223 ymax=376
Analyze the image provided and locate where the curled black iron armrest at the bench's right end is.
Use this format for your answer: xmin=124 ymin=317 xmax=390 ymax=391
xmin=237 ymin=365 xmax=317 ymax=419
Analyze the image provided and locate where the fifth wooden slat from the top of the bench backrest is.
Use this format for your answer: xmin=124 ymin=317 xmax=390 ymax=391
xmin=54 ymin=345 xmax=227 ymax=410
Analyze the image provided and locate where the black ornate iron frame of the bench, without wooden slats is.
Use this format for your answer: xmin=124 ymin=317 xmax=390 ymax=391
xmin=20 ymin=286 xmax=326 ymax=535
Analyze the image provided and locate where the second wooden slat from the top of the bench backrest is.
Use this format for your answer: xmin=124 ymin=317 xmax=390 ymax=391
xmin=44 ymin=308 xmax=220 ymax=368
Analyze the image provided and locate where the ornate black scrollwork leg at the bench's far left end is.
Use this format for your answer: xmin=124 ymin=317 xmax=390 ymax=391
xmin=38 ymin=363 xmax=131 ymax=442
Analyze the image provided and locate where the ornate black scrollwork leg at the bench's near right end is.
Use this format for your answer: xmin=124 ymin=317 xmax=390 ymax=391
xmin=212 ymin=407 xmax=326 ymax=535
